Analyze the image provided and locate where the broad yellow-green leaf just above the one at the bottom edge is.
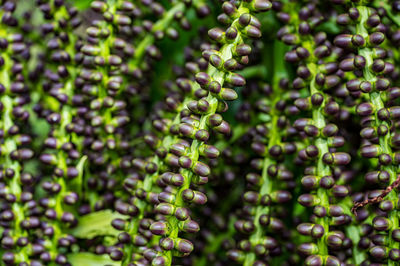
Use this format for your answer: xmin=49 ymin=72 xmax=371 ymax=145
xmin=70 ymin=210 xmax=128 ymax=238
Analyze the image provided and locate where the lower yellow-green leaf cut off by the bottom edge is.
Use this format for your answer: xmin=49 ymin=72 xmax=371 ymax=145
xmin=67 ymin=252 xmax=121 ymax=266
